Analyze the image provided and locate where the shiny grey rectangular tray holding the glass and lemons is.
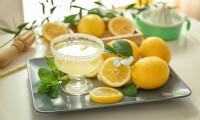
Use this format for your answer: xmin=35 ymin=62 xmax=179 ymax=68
xmin=27 ymin=58 xmax=191 ymax=112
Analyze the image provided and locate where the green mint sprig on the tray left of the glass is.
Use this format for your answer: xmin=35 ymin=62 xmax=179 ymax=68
xmin=38 ymin=57 xmax=70 ymax=99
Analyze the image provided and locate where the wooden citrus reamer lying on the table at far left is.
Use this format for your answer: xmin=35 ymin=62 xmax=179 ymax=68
xmin=0 ymin=31 xmax=35 ymax=69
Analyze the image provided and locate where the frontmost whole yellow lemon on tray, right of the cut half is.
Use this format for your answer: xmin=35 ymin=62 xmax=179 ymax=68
xmin=132 ymin=57 xmax=169 ymax=89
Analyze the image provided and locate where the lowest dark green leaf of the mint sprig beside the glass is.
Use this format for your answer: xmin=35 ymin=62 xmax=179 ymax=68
xmin=47 ymin=85 xmax=60 ymax=99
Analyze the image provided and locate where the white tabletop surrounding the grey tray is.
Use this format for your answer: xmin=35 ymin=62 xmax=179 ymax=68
xmin=0 ymin=0 xmax=200 ymax=120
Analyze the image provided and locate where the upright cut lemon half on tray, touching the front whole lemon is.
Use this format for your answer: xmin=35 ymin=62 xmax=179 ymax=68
xmin=99 ymin=57 xmax=131 ymax=87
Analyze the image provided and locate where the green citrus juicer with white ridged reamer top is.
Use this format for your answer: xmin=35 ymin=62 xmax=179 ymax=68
xmin=135 ymin=2 xmax=190 ymax=41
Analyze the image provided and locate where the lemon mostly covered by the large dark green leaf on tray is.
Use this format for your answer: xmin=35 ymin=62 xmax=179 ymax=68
xmin=108 ymin=39 xmax=140 ymax=63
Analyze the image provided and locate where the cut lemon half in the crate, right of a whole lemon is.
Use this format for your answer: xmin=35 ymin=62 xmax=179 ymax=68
xmin=108 ymin=17 xmax=135 ymax=35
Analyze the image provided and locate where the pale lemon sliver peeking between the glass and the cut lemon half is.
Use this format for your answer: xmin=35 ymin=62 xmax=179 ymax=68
xmin=86 ymin=57 xmax=104 ymax=78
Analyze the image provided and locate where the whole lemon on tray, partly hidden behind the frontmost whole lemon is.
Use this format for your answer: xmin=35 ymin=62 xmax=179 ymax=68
xmin=140 ymin=37 xmax=171 ymax=63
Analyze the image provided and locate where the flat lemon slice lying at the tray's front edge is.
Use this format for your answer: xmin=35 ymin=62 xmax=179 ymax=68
xmin=89 ymin=87 xmax=123 ymax=104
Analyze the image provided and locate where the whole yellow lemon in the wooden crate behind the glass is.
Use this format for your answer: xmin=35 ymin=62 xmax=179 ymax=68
xmin=77 ymin=14 xmax=105 ymax=37
